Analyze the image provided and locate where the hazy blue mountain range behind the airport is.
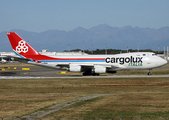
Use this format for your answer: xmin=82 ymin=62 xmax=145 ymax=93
xmin=0 ymin=24 xmax=169 ymax=51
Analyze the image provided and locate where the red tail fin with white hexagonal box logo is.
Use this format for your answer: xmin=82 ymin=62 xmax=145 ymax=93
xmin=7 ymin=32 xmax=40 ymax=58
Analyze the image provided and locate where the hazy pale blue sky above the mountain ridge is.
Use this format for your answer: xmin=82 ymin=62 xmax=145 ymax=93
xmin=0 ymin=0 xmax=169 ymax=32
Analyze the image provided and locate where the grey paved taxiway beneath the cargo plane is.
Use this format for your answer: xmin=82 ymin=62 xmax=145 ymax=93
xmin=0 ymin=63 xmax=169 ymax=79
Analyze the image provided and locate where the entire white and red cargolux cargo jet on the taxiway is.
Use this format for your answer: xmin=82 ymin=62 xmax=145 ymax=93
xmin=7 ymin=32 xmax=167 ymax=75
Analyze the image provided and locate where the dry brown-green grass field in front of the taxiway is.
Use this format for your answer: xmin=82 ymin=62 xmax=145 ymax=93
xmin=0 ymin=78 xmax=169 ymax=119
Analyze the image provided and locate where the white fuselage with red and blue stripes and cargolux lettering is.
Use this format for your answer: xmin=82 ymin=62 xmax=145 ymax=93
xmin=29 ymin=52 xmax=167 ymax=71
